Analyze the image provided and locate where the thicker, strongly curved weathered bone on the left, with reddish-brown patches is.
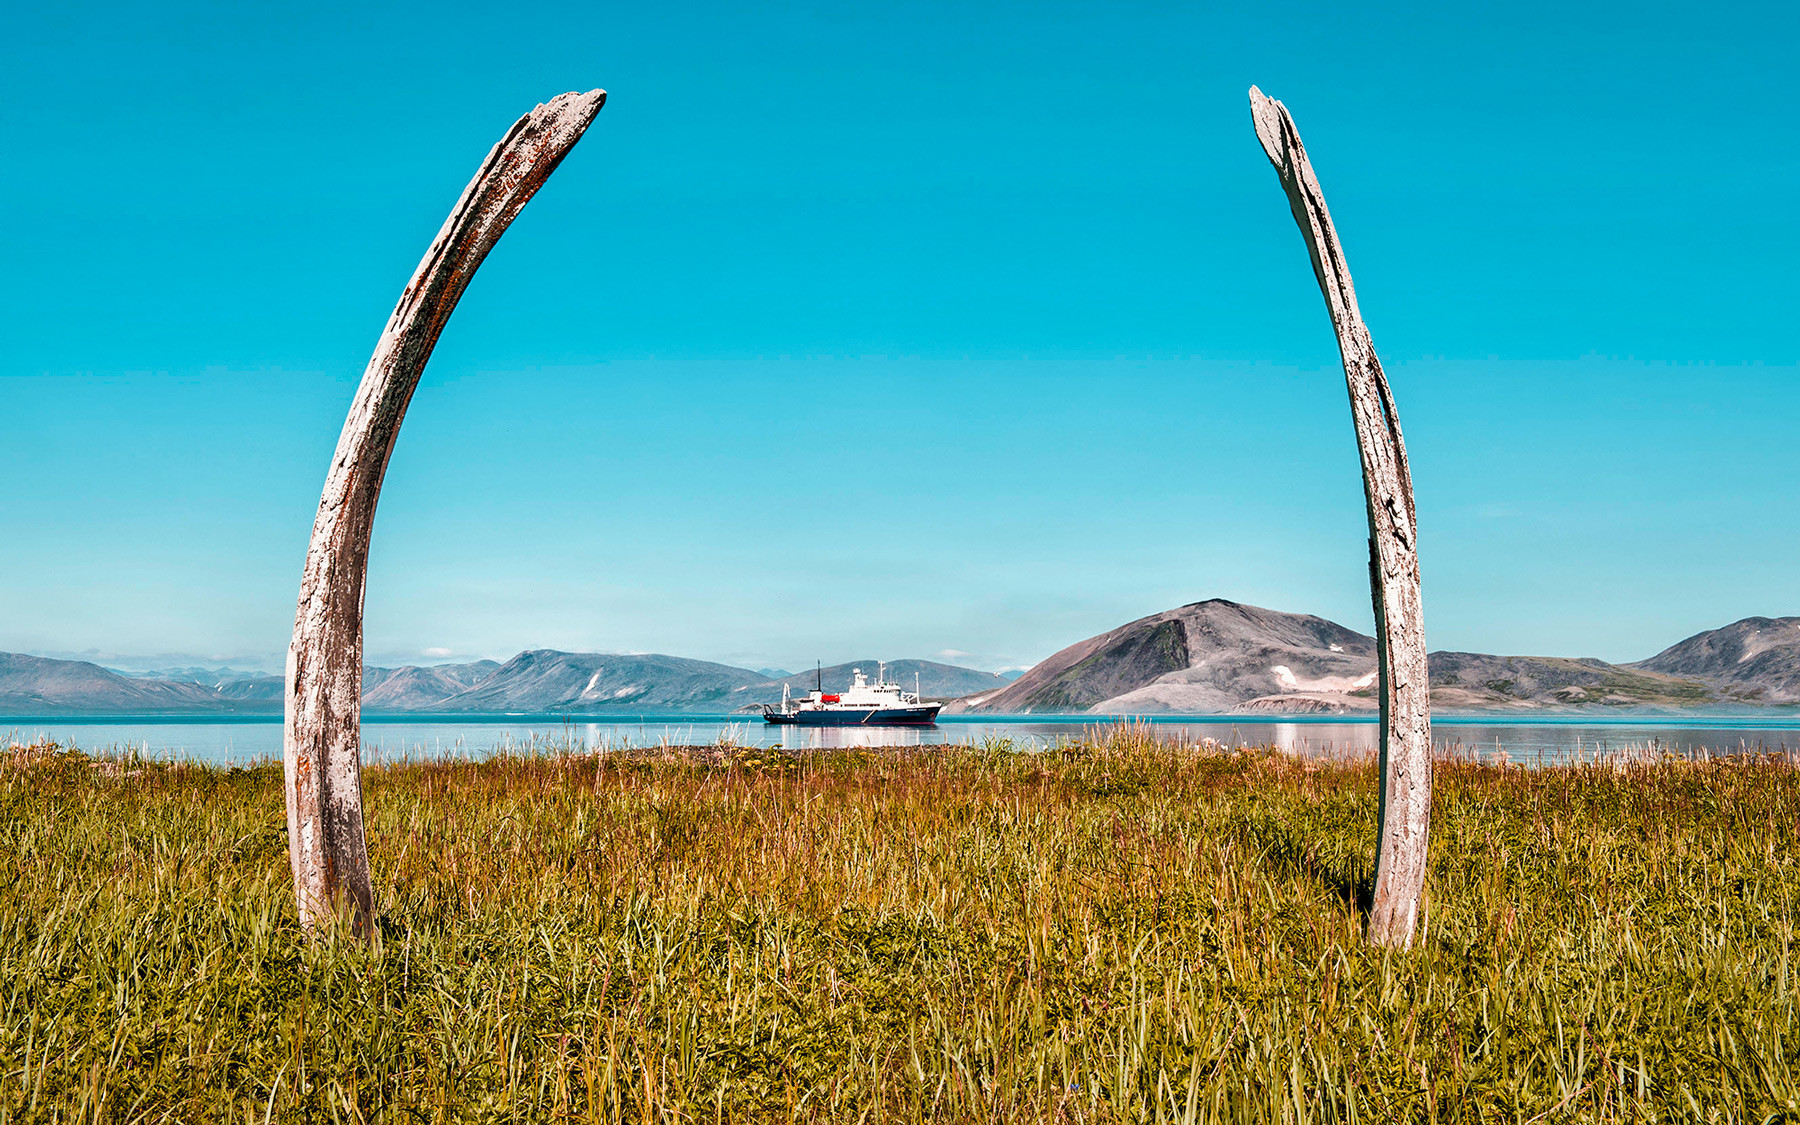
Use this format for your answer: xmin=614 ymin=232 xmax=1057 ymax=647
xmin=283 ymin=90 xmax=607 ymax=936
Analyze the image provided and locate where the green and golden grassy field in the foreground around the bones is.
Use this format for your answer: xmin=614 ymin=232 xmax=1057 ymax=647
xmin=0 ymin=731 xmax=1800 ymax=1121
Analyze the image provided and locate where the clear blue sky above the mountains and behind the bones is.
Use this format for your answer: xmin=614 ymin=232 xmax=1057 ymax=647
xmin=0 ymin=4 xmax=1800 ymax=668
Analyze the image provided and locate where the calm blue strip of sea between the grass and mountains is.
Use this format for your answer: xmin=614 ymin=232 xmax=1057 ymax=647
xmin=0 ymin=711 xmax=1800 ymax=765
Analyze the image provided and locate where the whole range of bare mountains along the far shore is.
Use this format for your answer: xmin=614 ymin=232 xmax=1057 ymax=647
xmin=0 ymin=598 xmax=1800 ymax=716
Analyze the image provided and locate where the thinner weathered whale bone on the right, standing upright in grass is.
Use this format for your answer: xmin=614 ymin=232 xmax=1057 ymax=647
xmin=1249 ymin=86 xmax=1431 ymax=947
